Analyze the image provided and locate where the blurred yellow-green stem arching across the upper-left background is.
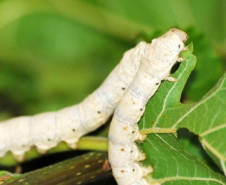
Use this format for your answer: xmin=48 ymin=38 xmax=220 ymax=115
xmin=0 ymin=0 xmax=152 ymax=42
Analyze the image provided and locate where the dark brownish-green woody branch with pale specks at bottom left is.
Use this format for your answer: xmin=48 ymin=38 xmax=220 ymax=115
xmin=0 ymin=152 xmax=111 ymax=185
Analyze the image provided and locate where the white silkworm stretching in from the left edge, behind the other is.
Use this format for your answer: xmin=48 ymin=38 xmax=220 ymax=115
xmin=0 ymin=42 xmax=146 ymax=161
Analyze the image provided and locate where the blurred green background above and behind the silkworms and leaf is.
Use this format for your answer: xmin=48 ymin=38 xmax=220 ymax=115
xmin=0 ymin=0 xmax=226 ymax=119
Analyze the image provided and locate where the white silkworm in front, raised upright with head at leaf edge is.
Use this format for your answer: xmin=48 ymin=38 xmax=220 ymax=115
xmin=109 ymin=28 xmax=187 ymax=185
